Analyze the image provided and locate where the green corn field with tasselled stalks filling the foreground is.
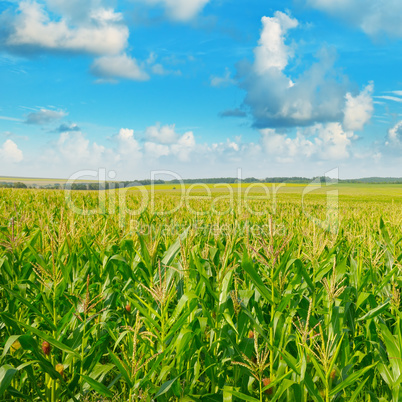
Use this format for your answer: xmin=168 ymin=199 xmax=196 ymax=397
xmin=0 ymin=185 xmax=402 ymax=402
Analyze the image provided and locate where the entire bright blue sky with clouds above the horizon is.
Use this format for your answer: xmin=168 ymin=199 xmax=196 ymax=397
xmin=0 ymin=0 xmax=402 ymax=180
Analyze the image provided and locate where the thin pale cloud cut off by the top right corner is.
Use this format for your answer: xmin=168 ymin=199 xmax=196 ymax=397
xmin=307 ymin=0 xmax=402 ymax=38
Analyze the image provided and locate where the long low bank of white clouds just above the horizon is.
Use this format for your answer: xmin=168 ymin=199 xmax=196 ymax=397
xmin=23 ymin=116 xmax=370 ymax=180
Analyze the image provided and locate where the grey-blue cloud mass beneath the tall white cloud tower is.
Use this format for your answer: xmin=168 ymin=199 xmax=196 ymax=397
xmin=240 ymin=44 xmax=346 ymax=128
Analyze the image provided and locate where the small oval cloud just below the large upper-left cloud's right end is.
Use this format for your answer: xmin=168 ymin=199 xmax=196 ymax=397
xmin=91 ymin=53 xmax=149 ymax=81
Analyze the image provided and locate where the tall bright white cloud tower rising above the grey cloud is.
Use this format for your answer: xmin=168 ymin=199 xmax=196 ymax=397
xmin=254 ymin=11 xmax=298 ymax=74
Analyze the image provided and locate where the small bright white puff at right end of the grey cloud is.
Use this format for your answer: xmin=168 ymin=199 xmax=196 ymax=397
xmin=343 ymin=83 xmax=374 ymax=131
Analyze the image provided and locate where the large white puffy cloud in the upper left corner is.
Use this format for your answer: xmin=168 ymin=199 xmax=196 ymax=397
xmin=5 ymin=1 xmax=129 ymax=55
